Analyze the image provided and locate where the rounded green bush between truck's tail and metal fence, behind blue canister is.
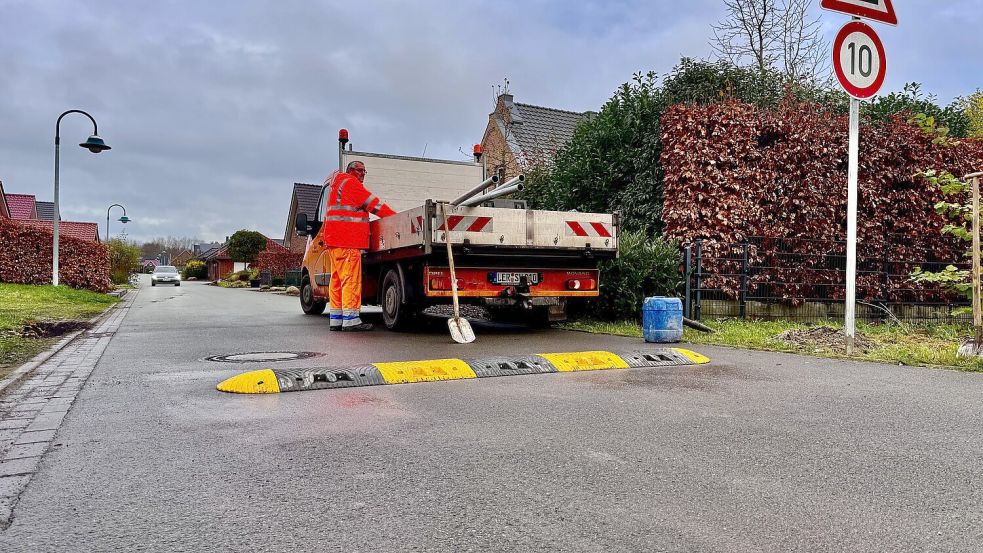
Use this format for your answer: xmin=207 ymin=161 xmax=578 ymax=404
xmin=571 ymin=231 xmax=683 ymax=320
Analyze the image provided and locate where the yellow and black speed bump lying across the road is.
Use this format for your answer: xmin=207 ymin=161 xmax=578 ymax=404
xmin=217 ymin=348 xmax=710 ymax=394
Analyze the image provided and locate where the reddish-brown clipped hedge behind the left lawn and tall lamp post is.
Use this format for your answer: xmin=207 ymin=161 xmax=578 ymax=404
xmin=0 ymin=219 xmax=112 ymax=292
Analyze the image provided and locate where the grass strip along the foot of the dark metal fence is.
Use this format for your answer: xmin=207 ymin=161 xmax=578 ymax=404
xmin=561 ymin=320 xmax=983 ymax=372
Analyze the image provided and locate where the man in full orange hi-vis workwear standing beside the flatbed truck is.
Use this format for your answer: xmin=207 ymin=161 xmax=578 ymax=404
xmin=324 ymin=161 xmax=396 ymax=331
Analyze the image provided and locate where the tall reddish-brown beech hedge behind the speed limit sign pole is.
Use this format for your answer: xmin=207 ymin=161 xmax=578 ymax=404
xmin=661 ymin=102 xmax=983 ymax=303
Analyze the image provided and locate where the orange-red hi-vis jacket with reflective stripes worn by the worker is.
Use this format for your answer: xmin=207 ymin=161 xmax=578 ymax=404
xmin=324 ymin=173 xmax=396 ymax=250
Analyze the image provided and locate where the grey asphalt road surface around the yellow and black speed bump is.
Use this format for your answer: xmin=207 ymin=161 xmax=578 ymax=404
xmin=0 ymin=283 xmax=983 ymax=552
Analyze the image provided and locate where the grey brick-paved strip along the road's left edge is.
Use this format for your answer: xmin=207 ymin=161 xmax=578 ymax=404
xmin=0 ymin=291 xmax=136 ymax=530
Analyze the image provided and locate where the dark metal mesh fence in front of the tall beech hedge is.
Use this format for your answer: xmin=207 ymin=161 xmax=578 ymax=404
xmin=683 ymin=236 xmax=969 ymax=322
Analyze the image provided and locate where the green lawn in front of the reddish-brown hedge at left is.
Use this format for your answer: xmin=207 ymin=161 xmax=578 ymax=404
xmin=0 ymin=283 xmax=119 ymax=378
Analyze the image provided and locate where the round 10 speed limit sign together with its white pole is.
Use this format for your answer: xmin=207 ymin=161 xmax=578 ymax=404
xmin=833 ymin=21 xmax=887 ymax=354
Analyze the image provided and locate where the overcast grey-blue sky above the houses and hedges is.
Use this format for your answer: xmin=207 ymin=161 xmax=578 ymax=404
xmin=0 ymin=0 xmax=983 ymax=241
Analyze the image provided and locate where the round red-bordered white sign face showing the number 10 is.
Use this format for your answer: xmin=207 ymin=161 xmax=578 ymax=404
xmin=833 ymin=21 xmax=887 ymax=100
